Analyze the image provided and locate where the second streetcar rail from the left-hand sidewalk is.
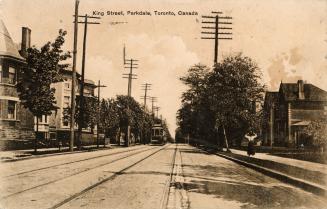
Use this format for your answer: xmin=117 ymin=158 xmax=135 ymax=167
xmin=0 ymin=145 xmax=159 ymax=199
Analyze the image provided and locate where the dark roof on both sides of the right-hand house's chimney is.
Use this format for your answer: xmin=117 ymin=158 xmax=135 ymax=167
xmin=279 ymin=83 xmax=327 ymax=101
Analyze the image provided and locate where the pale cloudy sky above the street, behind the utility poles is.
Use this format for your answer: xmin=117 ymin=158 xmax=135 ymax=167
xmin=0 ymin=0 xmax=327 ymax=135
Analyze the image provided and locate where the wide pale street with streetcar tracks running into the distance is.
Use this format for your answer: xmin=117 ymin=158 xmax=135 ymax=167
xmin=0 ymin=144 xmax=327 ymax=209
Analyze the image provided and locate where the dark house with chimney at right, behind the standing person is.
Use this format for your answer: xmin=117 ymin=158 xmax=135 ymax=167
xmin=262 ymin=80 xmax=327 ymax=147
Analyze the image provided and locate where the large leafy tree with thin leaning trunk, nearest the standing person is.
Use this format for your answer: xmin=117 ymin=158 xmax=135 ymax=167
xmin=208 ymin=54 xmax=264 ymax=150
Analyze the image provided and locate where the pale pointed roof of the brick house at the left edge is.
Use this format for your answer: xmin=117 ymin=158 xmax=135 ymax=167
xmin=0 ymin=19 xmax=24 ymax=60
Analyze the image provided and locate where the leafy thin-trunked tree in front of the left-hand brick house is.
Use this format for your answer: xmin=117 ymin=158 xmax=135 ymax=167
xmin=17 ymin=30 xmax=70 ymax=152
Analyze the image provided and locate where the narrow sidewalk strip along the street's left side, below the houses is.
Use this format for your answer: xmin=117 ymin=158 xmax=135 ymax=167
xmin=0 ymin=144 xmax=116 ymax=162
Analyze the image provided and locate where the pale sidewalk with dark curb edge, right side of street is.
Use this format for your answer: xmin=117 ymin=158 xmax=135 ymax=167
xmin=191 ymin=140 xmax=327 ymax=195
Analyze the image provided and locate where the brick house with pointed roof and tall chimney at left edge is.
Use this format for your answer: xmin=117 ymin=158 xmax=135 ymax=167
xmin=0 ymin=20 xmax=34 ymax=148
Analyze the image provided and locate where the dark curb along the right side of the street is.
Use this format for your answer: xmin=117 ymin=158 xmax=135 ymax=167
xmin=214 ymin=153 xmax=327 ymax=196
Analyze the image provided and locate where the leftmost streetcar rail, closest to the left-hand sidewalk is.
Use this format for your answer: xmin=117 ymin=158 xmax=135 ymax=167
xmin=2 ymin=147 xmax=149 ymax=178
